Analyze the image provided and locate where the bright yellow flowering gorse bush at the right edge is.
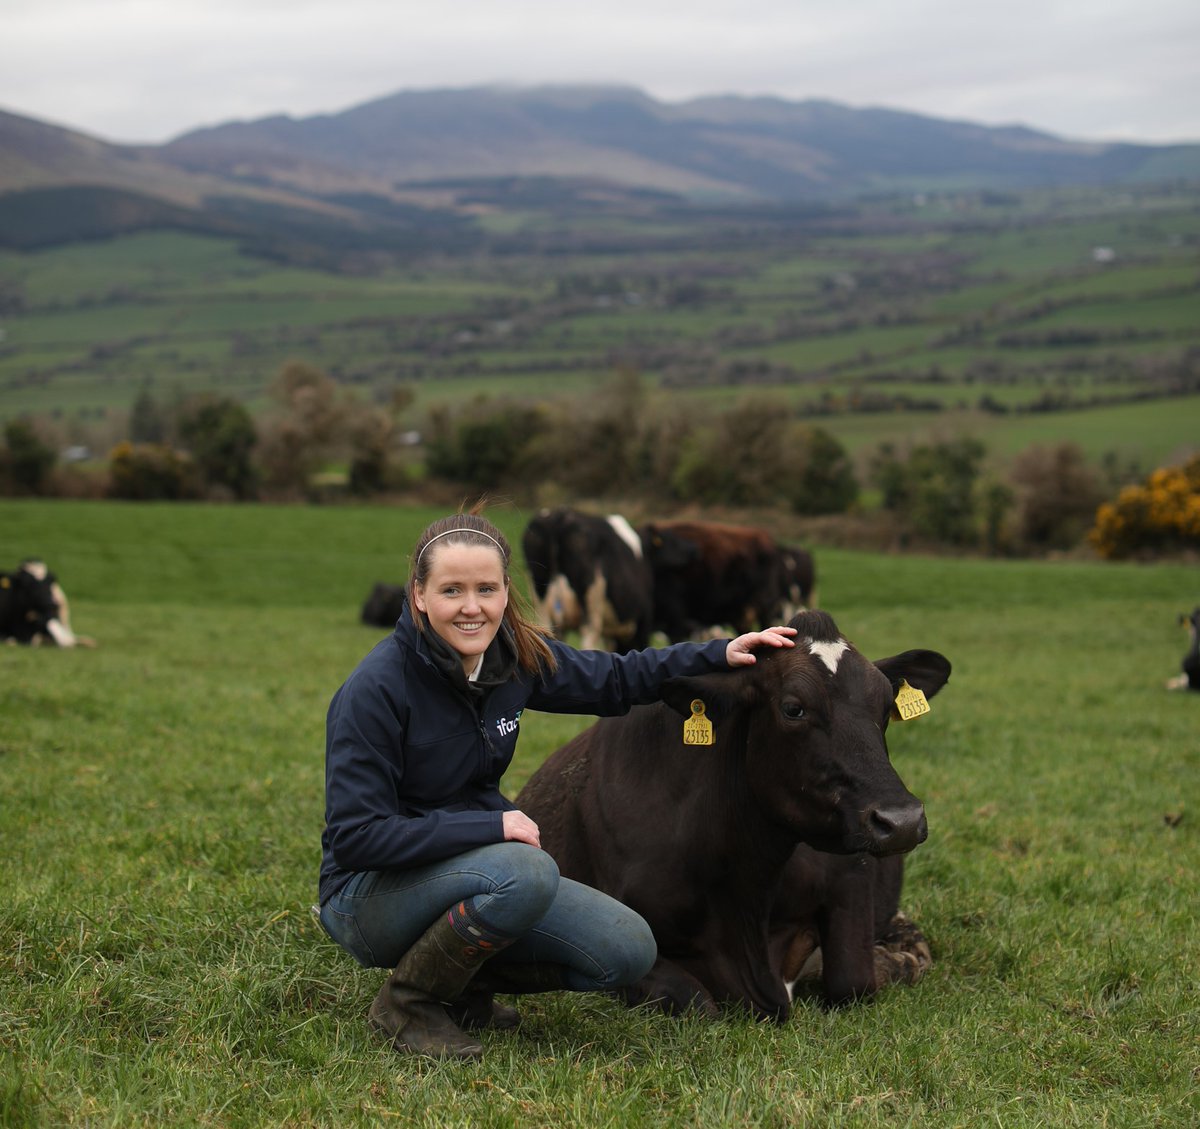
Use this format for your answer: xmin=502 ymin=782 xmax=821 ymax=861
xmin=1087 ymin=455 xmax=1200 ymax=560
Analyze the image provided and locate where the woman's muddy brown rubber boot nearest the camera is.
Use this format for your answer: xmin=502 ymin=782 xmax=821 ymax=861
xmin=367 ymin=913 xmax=511 ymax=1058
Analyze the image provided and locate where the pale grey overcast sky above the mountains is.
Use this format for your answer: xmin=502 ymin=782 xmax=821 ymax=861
xmin=7 ymin=0 xmax=1200 ymax=142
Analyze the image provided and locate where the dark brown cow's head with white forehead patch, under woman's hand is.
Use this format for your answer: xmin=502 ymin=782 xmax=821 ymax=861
xmin=662 ymin=612 xmax=950 ymax=855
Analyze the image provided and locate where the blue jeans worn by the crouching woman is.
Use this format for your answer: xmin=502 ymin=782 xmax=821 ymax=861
xmin=320 ymin=842 xmax=658 ymax=992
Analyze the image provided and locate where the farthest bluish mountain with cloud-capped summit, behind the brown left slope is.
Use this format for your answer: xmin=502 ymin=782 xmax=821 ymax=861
xmin=160 ymin=86 xmax=1200 ymax=200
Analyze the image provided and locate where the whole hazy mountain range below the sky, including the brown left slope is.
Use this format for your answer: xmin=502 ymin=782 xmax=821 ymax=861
xmin=0 ymin=86 xmax=1200 ymax=260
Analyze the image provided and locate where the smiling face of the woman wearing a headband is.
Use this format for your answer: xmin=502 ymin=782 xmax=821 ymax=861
xmin=413 ymin=545 xmax=509 ymax=674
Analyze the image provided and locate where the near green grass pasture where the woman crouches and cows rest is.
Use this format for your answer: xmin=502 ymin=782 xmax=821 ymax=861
xmin=0 ymin=500 xmax=1200 ymax=1129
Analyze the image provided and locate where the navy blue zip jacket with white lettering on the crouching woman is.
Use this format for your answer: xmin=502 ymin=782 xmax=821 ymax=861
xmin=319 ymin=607 xmax=728 ymax=905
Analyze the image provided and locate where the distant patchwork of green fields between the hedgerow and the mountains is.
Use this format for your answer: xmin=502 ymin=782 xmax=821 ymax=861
xmin=0 ymin=181 xmax=1200 ymax=475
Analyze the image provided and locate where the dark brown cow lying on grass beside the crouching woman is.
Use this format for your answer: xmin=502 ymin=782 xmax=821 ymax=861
xmin=516 ymin=611 xmax=950 ymax=1021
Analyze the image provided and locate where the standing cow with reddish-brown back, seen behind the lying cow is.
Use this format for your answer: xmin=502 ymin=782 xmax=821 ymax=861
xmin=638 ymin=521 xmax=784 ymax=643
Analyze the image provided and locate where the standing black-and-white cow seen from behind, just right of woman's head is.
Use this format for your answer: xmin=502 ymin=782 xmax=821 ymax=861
xmin=521 ymin=506 xmax=654 ymax=653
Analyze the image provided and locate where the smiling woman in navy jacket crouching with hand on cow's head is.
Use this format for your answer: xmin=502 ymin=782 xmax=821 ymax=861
xmin=320 ymin=514 xmax=794 ymax=1058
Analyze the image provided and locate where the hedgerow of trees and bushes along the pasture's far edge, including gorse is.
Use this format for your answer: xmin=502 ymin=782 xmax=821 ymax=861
xmin=0 ymin=361 xmax=1200 ymax=558
